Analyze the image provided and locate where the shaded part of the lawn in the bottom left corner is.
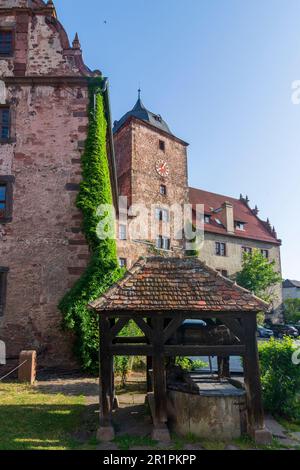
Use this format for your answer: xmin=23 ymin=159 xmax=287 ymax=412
xmin=0 ymin=403 xmax=85 ymax=450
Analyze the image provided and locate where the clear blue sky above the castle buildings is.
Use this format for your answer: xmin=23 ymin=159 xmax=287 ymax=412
xmin=55 ymin=0 xmax=300 ymax=279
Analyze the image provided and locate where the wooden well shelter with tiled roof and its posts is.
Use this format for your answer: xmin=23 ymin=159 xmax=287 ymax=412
xmin=90 ymin=257 xmax=270 ymax=442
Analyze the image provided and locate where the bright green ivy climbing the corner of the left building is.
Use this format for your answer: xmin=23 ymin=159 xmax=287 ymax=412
xmin=59 ymin=78 xmax=124 ymax=373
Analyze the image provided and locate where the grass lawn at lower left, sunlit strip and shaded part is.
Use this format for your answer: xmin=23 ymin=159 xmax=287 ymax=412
xmin=0 ymin=383 xmax=85 ymax=450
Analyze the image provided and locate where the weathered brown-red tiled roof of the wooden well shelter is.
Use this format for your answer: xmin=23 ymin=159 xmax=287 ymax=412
xmin=90 ymin=257 xmax=268 ymax=312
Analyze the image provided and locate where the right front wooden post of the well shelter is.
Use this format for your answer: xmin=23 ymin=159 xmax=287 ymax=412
xmin=243 ymin=313 xmax=272 ymax=444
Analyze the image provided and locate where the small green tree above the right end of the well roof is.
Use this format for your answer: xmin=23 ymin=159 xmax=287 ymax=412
xmin=236 ymin=250 xmax=282 ymax=302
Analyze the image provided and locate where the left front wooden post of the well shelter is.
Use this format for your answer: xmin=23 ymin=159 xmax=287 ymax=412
xmin=97 ymin=314 xmax=114 ymax=442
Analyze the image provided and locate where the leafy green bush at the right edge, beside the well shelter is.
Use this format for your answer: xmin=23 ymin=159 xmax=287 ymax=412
xmin=259 ymin=337 xmax=300 ymax=418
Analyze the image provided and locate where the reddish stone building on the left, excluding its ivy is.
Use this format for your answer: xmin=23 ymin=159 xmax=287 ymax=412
xmin=0 ymin=0 xmax=113 ymax=367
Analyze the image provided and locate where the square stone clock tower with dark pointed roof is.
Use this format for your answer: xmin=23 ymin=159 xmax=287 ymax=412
xmin=113 ymin=92 xmax=188 ymax=267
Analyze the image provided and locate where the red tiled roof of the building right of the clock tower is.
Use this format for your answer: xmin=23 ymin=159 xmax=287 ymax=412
xmin=189 ymin=188 xmax=281 ymax=245
